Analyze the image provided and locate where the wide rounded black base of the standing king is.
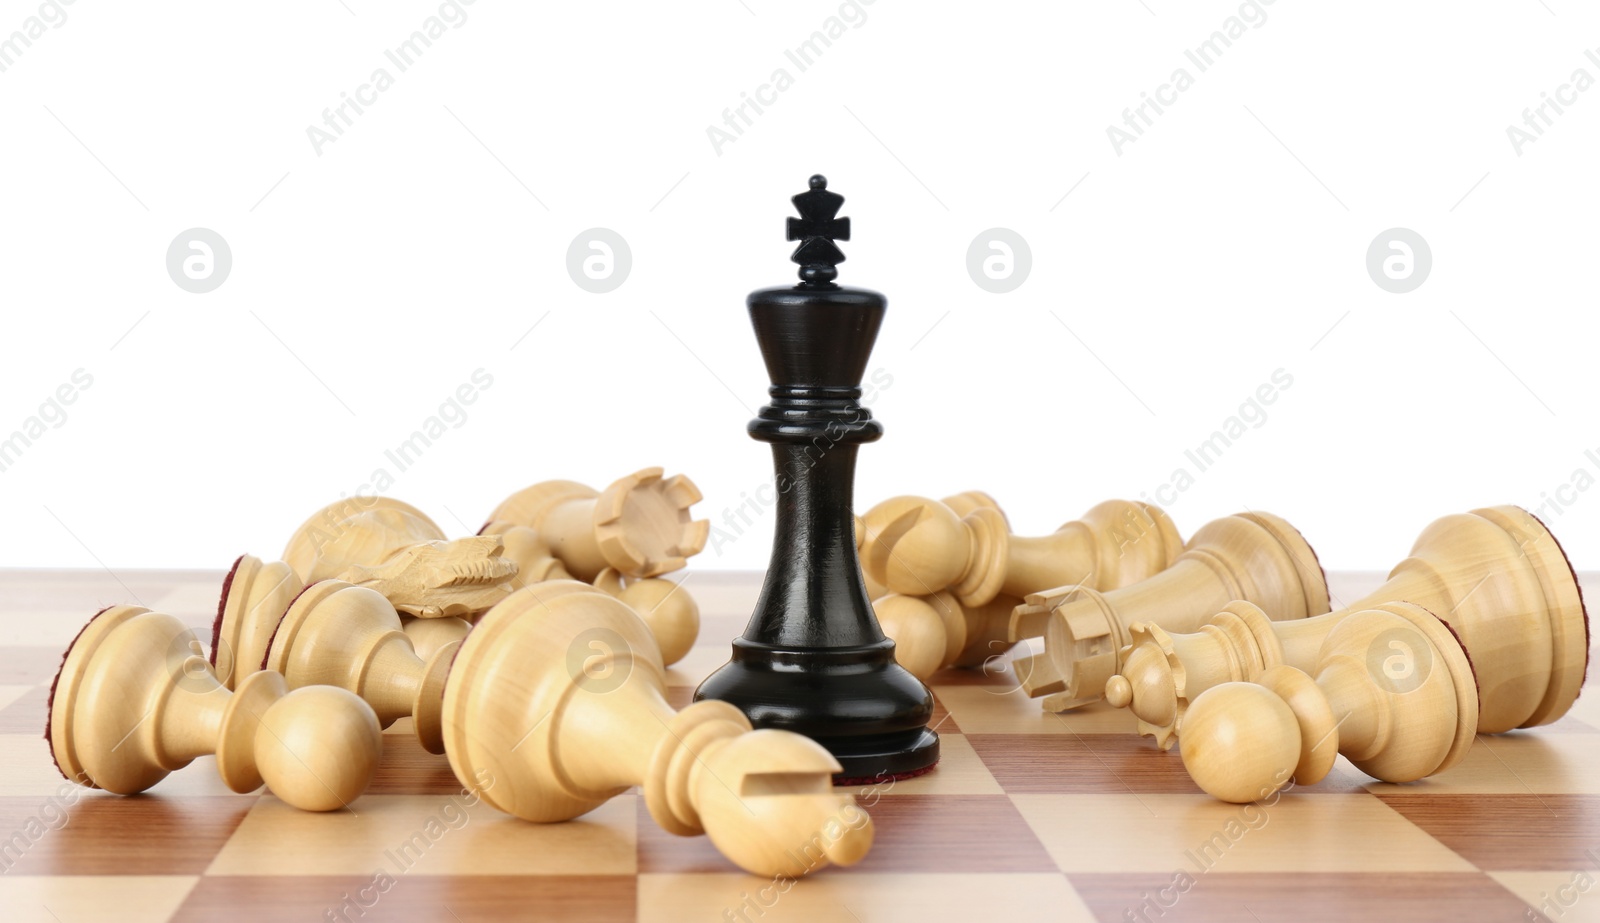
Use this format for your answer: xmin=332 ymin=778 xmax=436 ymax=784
xmin=694 ymin=638 xmax=939 ymax=785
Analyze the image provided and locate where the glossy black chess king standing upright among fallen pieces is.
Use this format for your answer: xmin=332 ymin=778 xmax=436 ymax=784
xmin=694 ymin=176 xmax=939 ymax=784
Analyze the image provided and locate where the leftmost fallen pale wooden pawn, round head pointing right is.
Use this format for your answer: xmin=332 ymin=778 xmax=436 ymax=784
xmin=46 ymin=606 xmax=382 ymax=811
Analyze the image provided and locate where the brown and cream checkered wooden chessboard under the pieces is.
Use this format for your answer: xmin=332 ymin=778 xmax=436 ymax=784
xmin=0 ymin=571 xmax=1600 ymax=923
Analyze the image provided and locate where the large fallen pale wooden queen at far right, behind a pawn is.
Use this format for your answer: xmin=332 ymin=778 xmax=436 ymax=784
xmin=1107 ymin=505 xmax=1589 ymax=749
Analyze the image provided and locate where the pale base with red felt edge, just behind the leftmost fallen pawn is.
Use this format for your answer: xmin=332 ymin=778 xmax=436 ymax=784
xmin=211 ymin=555 xmax=306 ymax=689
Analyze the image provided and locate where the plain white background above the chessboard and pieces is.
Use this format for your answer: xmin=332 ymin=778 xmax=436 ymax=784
xmin=0 ymin=0 xmax=1600 ymax=568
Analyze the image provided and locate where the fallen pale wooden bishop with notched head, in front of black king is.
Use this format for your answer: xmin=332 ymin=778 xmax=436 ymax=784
xmin=443 ymin=581 xmax=872 ymax=877
